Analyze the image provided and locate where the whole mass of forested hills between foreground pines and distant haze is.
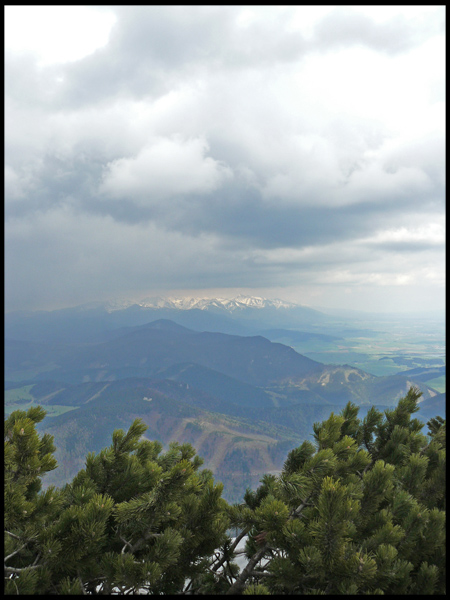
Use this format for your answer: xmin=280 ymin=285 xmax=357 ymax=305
xmin=5 ymin=319 xmax=445 ymax=501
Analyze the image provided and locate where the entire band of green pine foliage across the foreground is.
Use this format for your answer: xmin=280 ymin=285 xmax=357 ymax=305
xmin=5 ymin=389 xmax=446 ymax=595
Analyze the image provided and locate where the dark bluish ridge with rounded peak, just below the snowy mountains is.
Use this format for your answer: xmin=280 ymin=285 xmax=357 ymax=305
xmin=5 ymin=320 xmax=322 ymax=386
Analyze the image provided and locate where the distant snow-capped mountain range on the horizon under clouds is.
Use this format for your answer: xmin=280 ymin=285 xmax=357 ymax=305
xmin=106 ymin=296 xmax=300 ymax=312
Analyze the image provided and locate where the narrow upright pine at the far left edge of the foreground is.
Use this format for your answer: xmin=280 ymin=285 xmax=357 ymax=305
xmin=4 ymin=407 xmax=62 ymax=594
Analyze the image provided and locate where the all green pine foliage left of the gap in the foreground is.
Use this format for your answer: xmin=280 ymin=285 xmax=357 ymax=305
xmin=5 ymin=408 xmax=232 ymax=594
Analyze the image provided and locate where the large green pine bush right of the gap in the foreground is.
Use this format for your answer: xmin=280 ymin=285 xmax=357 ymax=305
xmin=219 ymin=389 xmax=445 ymax=595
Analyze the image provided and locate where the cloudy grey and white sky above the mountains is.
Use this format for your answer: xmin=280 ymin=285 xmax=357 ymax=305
xmin=5 ymin=6 xmax=445 ymax=312
